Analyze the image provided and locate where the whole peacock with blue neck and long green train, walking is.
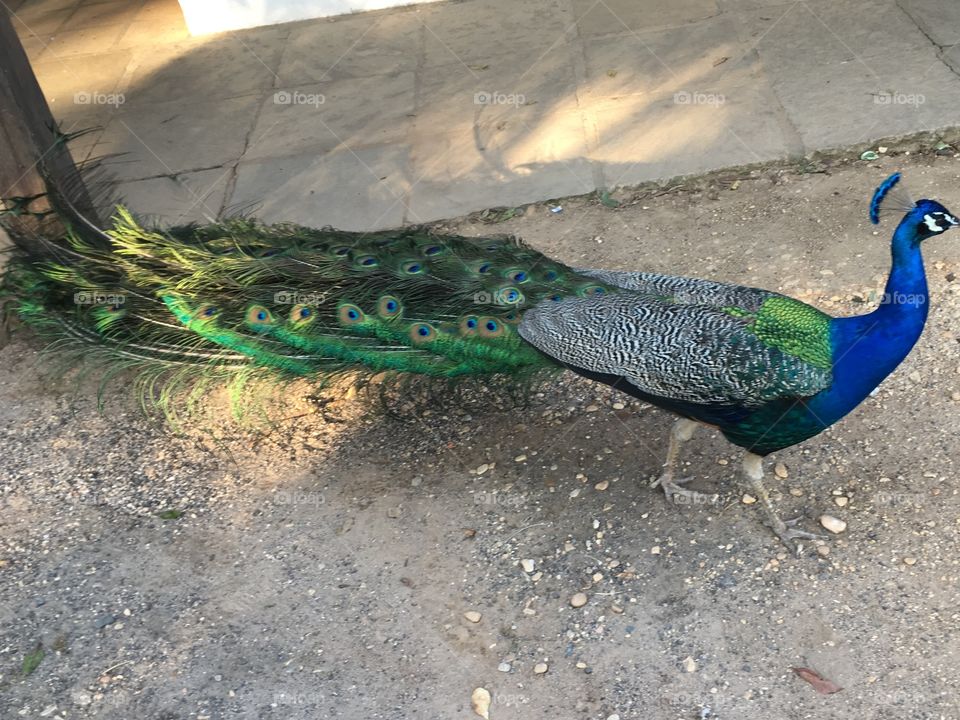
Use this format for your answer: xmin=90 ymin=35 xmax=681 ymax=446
xmin=4 ymin=173 xmax=957 ymax=546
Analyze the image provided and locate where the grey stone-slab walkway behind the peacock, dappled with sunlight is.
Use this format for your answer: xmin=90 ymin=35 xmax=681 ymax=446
xmin=7 ymin=0 xmax=960 ymax=229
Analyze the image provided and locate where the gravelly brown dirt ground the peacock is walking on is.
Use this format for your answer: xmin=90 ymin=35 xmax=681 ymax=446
xmin=0 ymin=149 xmax=960 ymax=720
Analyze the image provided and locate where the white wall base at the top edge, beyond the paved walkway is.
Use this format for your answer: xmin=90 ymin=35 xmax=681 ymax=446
xmin=180 ymin=0 xmax=440 ymax=35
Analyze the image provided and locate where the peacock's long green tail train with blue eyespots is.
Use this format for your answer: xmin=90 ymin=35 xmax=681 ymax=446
xmin=4 ymin=207 xmax=612 ymax=416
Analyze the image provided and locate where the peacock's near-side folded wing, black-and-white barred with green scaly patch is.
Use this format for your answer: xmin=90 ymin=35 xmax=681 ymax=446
xmin=519 ymin=292 xmax=832 ymax=408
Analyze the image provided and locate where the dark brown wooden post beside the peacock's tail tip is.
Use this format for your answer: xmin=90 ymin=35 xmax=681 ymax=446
xmin=0 ymin=9 xmax=96 ymax=241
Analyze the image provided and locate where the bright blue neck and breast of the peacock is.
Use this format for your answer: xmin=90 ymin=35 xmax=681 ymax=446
xmin=813 ymin=215 xmax=928 ymax=422
